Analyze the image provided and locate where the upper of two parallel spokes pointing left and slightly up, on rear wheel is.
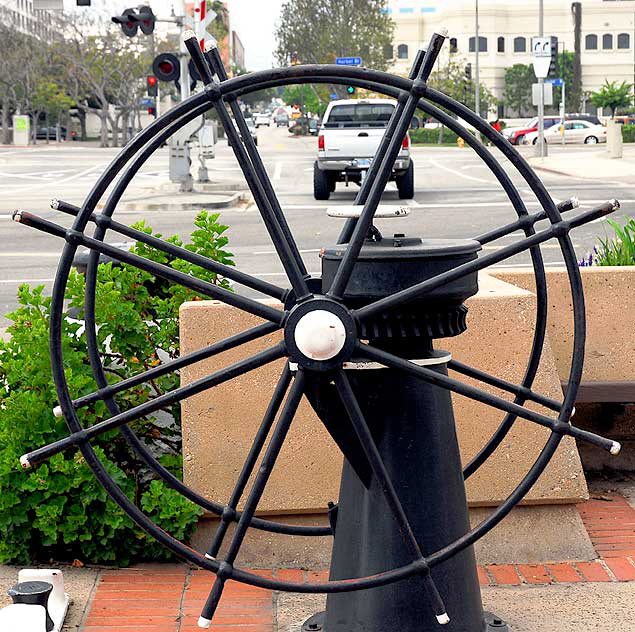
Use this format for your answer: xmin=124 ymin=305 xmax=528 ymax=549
xmin=51 ymin=200 xmax=288 ymax=302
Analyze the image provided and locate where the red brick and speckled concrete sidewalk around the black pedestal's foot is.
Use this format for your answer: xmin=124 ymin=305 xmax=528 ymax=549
xmin=46 ymin=493 xmax=635 ymax=632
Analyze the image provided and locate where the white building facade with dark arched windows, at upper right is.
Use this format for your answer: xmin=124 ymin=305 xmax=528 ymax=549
xmin=388 ymin=0 xmax=635 ymax=115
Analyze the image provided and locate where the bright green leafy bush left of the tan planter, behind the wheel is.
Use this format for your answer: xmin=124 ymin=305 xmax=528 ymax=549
xmin=0 ymin=212 xmax=233 ymax=565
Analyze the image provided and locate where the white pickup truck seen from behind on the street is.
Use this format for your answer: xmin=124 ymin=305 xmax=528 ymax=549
xmin=313 ymin=99 xmax=414 ymax=200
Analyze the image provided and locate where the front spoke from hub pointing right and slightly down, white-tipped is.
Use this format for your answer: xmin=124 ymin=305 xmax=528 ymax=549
xmin=356 ymin=343 xmax=620 ymax=454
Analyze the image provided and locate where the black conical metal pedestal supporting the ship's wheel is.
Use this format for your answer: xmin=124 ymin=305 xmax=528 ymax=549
xmin=325 ymin=364 xmax=488 ymax=632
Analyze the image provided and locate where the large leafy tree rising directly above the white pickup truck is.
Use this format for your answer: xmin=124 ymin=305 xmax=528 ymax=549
xmin=275 ymin=0 xmax=394 ymax=75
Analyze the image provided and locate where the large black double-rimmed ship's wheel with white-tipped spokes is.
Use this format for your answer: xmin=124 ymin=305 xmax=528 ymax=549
xmin=15 ymin=28 xmax=619 ymax=626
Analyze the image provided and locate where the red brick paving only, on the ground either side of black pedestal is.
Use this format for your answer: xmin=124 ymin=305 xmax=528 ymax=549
xmin=80 ymin=494 xmax=635 ymax=632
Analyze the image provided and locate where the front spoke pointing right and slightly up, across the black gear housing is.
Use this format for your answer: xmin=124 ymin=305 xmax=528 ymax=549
xmin=354 ymin=200 xmax=619 ymax=320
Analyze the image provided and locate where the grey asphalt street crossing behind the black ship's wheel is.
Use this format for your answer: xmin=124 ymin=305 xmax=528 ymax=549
xmin=0 ymin=127 xmax=635 ymax=327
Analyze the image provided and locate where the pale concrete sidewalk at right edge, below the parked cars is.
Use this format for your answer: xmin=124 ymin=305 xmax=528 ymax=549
xmin=527 ymin=144 xmax=635 ymax=184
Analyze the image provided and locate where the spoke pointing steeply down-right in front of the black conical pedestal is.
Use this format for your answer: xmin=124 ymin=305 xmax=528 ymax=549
xmin=335 ymin=369 xmax=449 ymax=623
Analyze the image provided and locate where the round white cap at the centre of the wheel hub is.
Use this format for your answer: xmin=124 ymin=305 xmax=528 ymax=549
xmin=293 ymin=309 xmax=346 ymax=360
